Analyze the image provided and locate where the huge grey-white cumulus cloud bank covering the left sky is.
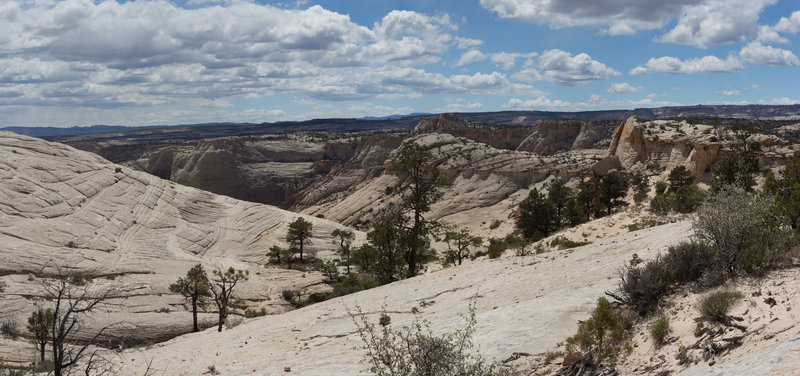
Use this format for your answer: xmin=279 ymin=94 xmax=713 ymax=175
xmin=0 ymin=0 xmax=494 ymax=123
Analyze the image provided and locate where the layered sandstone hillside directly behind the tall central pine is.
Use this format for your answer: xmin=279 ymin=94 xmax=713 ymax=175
xmin=306 ymin=133 xmax=603 ymax=231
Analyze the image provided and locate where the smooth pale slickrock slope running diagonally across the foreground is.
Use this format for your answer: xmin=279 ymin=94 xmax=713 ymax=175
xmin=114 ymin=222 xmax=690 ymax=375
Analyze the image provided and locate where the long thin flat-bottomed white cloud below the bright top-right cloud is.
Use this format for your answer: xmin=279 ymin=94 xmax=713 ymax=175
xmin=630 ymin=56 xmax=744 ymax=76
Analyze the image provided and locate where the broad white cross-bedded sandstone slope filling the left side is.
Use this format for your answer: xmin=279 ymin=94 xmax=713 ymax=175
xmin=0 ymin=132 xmax=363 ymax=362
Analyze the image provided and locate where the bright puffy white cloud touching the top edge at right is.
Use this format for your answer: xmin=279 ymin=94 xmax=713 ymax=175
xmin=658 ymin=0 xmax=777 ymax=48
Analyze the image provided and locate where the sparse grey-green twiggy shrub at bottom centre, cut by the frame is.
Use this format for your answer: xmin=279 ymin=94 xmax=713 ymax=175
xmin=350 ymin=301 xmax=508 ymax=376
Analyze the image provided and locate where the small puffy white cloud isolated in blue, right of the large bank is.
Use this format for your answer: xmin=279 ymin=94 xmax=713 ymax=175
xmin=539 ymin=50 xmax=620 ymax=86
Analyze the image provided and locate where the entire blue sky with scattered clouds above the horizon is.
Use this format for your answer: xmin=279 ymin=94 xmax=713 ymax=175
xmin=0 ymin=0 xmax=800 ymax=127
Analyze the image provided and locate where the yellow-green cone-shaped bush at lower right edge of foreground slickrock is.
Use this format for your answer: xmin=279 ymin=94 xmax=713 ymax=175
xmin=567 ymin=297 xmax=633 ymax=364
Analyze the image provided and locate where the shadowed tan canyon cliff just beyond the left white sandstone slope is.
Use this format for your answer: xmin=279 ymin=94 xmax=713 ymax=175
xmin=140 ymin=136 xmax=356 ymax=207
